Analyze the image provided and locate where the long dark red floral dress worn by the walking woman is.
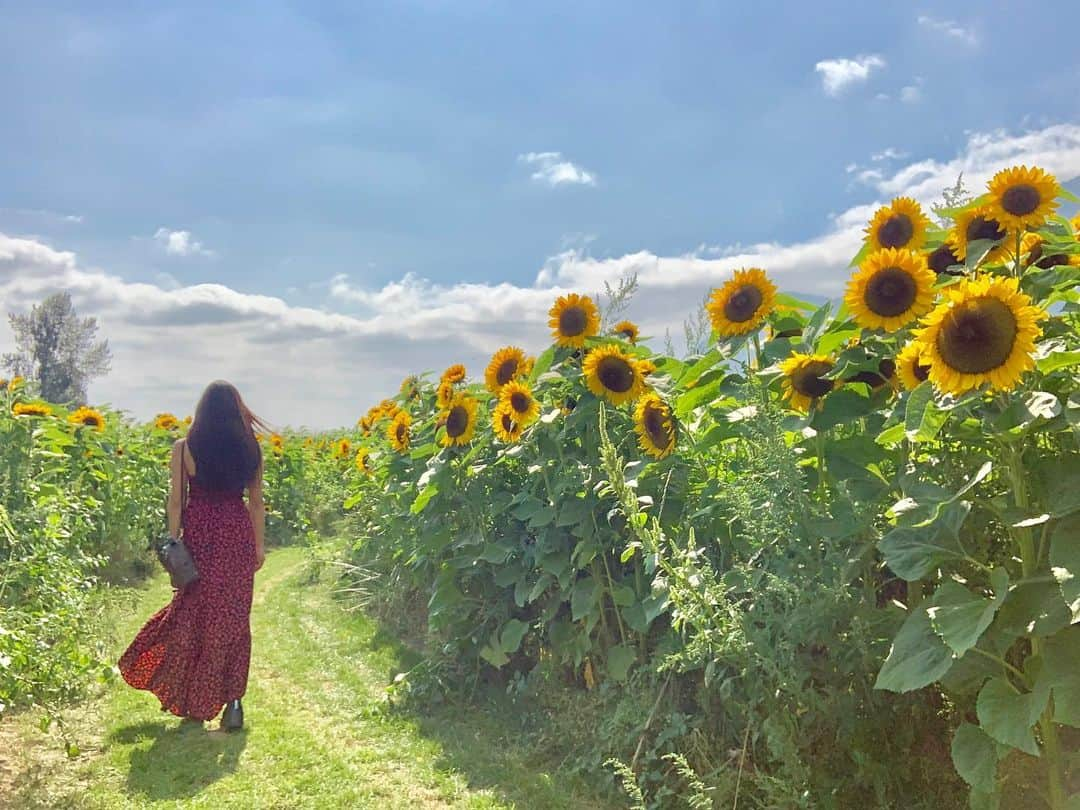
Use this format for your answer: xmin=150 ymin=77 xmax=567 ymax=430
xmin=120 ymin=478 xmax=256 ymax=720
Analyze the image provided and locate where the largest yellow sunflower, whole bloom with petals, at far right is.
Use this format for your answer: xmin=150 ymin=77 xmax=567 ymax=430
xmin=916 ymin=276 xmax=1047 ymax=394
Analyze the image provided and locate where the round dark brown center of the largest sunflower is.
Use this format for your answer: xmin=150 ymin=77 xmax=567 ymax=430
xmin=936 ymin=298 xmax=1017 ymax=374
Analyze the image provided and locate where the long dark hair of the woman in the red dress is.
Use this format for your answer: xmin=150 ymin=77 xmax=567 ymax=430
xmin=188 ymin=380 xmax=269 ymax=491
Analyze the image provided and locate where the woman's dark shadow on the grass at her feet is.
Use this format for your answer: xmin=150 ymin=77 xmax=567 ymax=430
xmin=109 ymin=721 xmax=247 ymax=800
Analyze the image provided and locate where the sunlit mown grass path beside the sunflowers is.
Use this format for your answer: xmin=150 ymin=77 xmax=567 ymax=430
xmin=0 ymin=549 xmax=605 ymax=810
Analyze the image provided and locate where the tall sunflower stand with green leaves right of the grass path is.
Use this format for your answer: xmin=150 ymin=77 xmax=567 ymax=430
xmin=308 ymin=166 xmax=1080 ymax=810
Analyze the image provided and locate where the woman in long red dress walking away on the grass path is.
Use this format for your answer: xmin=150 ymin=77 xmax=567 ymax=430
xmin=120 ymin=380 xmax=266 ymax=731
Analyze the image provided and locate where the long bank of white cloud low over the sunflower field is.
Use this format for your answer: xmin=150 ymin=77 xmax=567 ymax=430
xmin=0 ymin=124 xmax=1080 ymax=427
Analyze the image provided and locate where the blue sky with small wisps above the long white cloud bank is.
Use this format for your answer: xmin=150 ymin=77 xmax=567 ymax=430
xmin=0 ymin=0 xmax=1080 ymax=422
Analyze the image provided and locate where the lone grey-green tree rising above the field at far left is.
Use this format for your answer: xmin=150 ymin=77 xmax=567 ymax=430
xmin=3 ymin=293 xmax=112 ymax=404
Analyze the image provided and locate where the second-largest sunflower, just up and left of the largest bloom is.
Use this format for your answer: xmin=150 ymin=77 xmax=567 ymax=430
xmin=843 ymin=247 xmax=934 ymax=332
